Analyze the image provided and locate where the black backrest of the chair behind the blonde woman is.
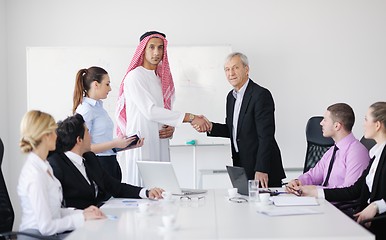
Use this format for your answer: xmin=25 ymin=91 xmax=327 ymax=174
xmin=0 ymin=138 xmax=15 ymax=236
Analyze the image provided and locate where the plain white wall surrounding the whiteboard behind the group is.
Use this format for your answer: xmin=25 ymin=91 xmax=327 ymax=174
xmin=4 ymin=0 xmax=386 ymax=230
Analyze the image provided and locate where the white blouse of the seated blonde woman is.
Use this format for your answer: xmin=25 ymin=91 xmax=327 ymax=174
xmin=17 ymin=152 xmax=84 ymax=235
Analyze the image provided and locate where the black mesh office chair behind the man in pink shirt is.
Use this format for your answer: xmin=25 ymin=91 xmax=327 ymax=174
xmin=303 ymin=116 xmax=334 ymax=173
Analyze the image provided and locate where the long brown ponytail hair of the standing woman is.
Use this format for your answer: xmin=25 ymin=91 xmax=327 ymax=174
xmin=72 ymin=67 xmax=108 ymax=113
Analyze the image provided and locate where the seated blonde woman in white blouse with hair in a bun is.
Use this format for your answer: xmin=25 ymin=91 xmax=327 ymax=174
xmin=17 ymin=110 xmax=105 ymax=239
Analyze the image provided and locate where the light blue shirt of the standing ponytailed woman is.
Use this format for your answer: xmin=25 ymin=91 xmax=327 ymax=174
xmin=76 ymin=97 xmax=115 ymax=156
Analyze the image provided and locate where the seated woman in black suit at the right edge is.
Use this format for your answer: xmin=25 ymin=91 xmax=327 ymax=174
xmin=300 ymin=102 xmax=386 ymax=239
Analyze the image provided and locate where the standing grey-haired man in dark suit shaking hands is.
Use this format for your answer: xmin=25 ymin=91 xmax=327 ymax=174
xmin=195 ymin=53 xmax=285 ymax=188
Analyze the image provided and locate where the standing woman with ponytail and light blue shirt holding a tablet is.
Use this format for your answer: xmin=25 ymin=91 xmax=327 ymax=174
xmin=72 ymin=67 xmax=143 ymax=181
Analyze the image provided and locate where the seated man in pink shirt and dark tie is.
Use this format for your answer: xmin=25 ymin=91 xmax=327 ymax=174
xmin=287 ymin=103 xmax=370 ymax=195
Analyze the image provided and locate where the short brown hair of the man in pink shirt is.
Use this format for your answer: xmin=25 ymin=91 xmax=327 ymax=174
xmin=327 ymin=103 xmax=355 ymax=132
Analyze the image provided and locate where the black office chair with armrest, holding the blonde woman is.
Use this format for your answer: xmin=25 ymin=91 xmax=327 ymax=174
xmin=0 ymin=138 xmax=58 ymax=240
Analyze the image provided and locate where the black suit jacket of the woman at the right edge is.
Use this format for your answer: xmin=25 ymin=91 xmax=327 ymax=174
xmin=324 ymin=147 xmax=386 ymax=239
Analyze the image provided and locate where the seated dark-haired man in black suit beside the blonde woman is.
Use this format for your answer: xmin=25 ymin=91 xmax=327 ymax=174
xmin=48 ymin=114 xmax=163 ymax=209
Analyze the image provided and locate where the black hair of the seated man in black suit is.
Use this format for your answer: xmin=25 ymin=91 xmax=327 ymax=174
xmin=56 ymin=113 xmax=85 ymax=152
